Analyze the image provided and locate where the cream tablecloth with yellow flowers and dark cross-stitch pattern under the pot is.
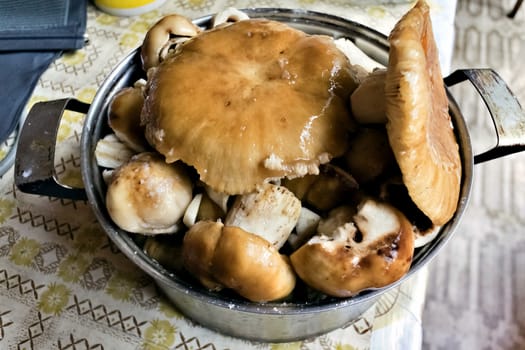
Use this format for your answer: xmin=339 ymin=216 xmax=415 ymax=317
xmin=0 ymin=0 xmax=456 ymax=349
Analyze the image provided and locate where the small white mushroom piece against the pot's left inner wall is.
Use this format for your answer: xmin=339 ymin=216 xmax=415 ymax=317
xmin=95 ymin=134 xmax=135 ymax=169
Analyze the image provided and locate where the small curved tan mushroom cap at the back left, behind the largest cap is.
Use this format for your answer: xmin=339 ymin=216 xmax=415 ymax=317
xmin=140 ymin=14 xmax=201 ymax=72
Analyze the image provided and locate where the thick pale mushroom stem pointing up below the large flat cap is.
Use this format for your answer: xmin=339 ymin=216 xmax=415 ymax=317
xmin=224 ymin=183 xmax=301 ymax=249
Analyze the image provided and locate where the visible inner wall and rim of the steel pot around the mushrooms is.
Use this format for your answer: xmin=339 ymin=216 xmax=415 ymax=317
xmin=81 ymin=9 xmax=473 ymax=315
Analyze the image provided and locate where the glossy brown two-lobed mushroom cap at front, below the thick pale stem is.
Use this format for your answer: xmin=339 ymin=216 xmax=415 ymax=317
xmin=182 ymin=221 xmax=295 ymax=302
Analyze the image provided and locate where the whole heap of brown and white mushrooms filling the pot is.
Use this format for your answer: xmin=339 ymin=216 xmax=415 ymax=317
xmin=95 ymin=1 xmax=461 ymax=302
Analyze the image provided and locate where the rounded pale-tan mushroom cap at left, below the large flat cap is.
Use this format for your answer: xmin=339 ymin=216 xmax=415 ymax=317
xmin=106 ymin=152 xmax=192 ymax=235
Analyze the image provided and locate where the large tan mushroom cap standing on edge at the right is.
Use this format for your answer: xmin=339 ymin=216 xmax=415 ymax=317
xmin=385 ymin=1 xmax=461 ymax=225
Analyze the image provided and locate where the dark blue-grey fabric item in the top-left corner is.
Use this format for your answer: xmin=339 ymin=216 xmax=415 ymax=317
xmin=0 ymin=0 xmax=87 ymax=142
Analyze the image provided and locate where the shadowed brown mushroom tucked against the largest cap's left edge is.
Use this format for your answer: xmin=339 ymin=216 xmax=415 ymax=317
xmin=108 ymin=82 xmax=148 ymax=152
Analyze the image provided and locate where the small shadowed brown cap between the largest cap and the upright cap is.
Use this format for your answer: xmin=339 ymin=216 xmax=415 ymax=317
xmin=350 ymin=69 xmax=387 ymax=125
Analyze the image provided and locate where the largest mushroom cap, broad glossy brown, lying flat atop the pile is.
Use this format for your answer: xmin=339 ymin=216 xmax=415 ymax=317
xmin=142 ymin=19 xmax=356 ymax=194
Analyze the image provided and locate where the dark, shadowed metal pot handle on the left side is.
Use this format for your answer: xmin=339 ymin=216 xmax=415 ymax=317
xmin=15 ymin=98 xmax=90 ymax=200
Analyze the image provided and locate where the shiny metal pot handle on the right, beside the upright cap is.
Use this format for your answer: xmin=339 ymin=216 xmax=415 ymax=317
xmin=444 ymin=69 xmax=525 ymax=164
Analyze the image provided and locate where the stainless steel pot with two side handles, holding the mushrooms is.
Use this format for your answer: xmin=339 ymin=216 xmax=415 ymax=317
xmin=15 ymin=9 xmax=525 ymax=342
